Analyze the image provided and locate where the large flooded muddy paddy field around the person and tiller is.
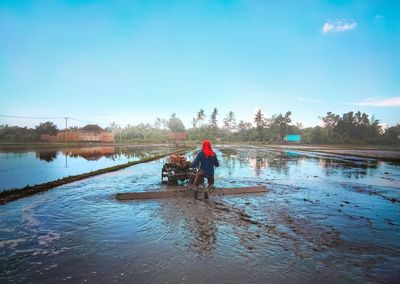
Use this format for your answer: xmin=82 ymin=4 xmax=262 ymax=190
xmin=0 ymin=147 xmax=400 ymax=283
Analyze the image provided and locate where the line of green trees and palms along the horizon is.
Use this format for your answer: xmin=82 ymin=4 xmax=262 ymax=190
xmin=0 ymin=108 xmax=400 ymax=144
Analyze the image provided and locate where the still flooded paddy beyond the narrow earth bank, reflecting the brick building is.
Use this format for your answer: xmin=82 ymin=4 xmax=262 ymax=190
xmin=0 ymin=146 xmax=172 ymax=192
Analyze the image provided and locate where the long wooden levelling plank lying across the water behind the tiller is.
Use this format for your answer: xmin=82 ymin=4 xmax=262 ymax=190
xmin=116 ymin=186 xmax=268 ymax=200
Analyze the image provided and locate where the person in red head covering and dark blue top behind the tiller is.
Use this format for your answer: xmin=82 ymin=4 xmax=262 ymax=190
xmin=192 ymin=140 xmax=219 ymax=199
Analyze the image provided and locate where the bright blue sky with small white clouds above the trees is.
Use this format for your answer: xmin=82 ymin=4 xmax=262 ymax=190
xmin=0 ymin=0 xmax=400 ymax=126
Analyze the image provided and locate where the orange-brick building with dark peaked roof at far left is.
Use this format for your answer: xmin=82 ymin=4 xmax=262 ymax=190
xmin=40 ymin=124 xmax=115 ymax=143
